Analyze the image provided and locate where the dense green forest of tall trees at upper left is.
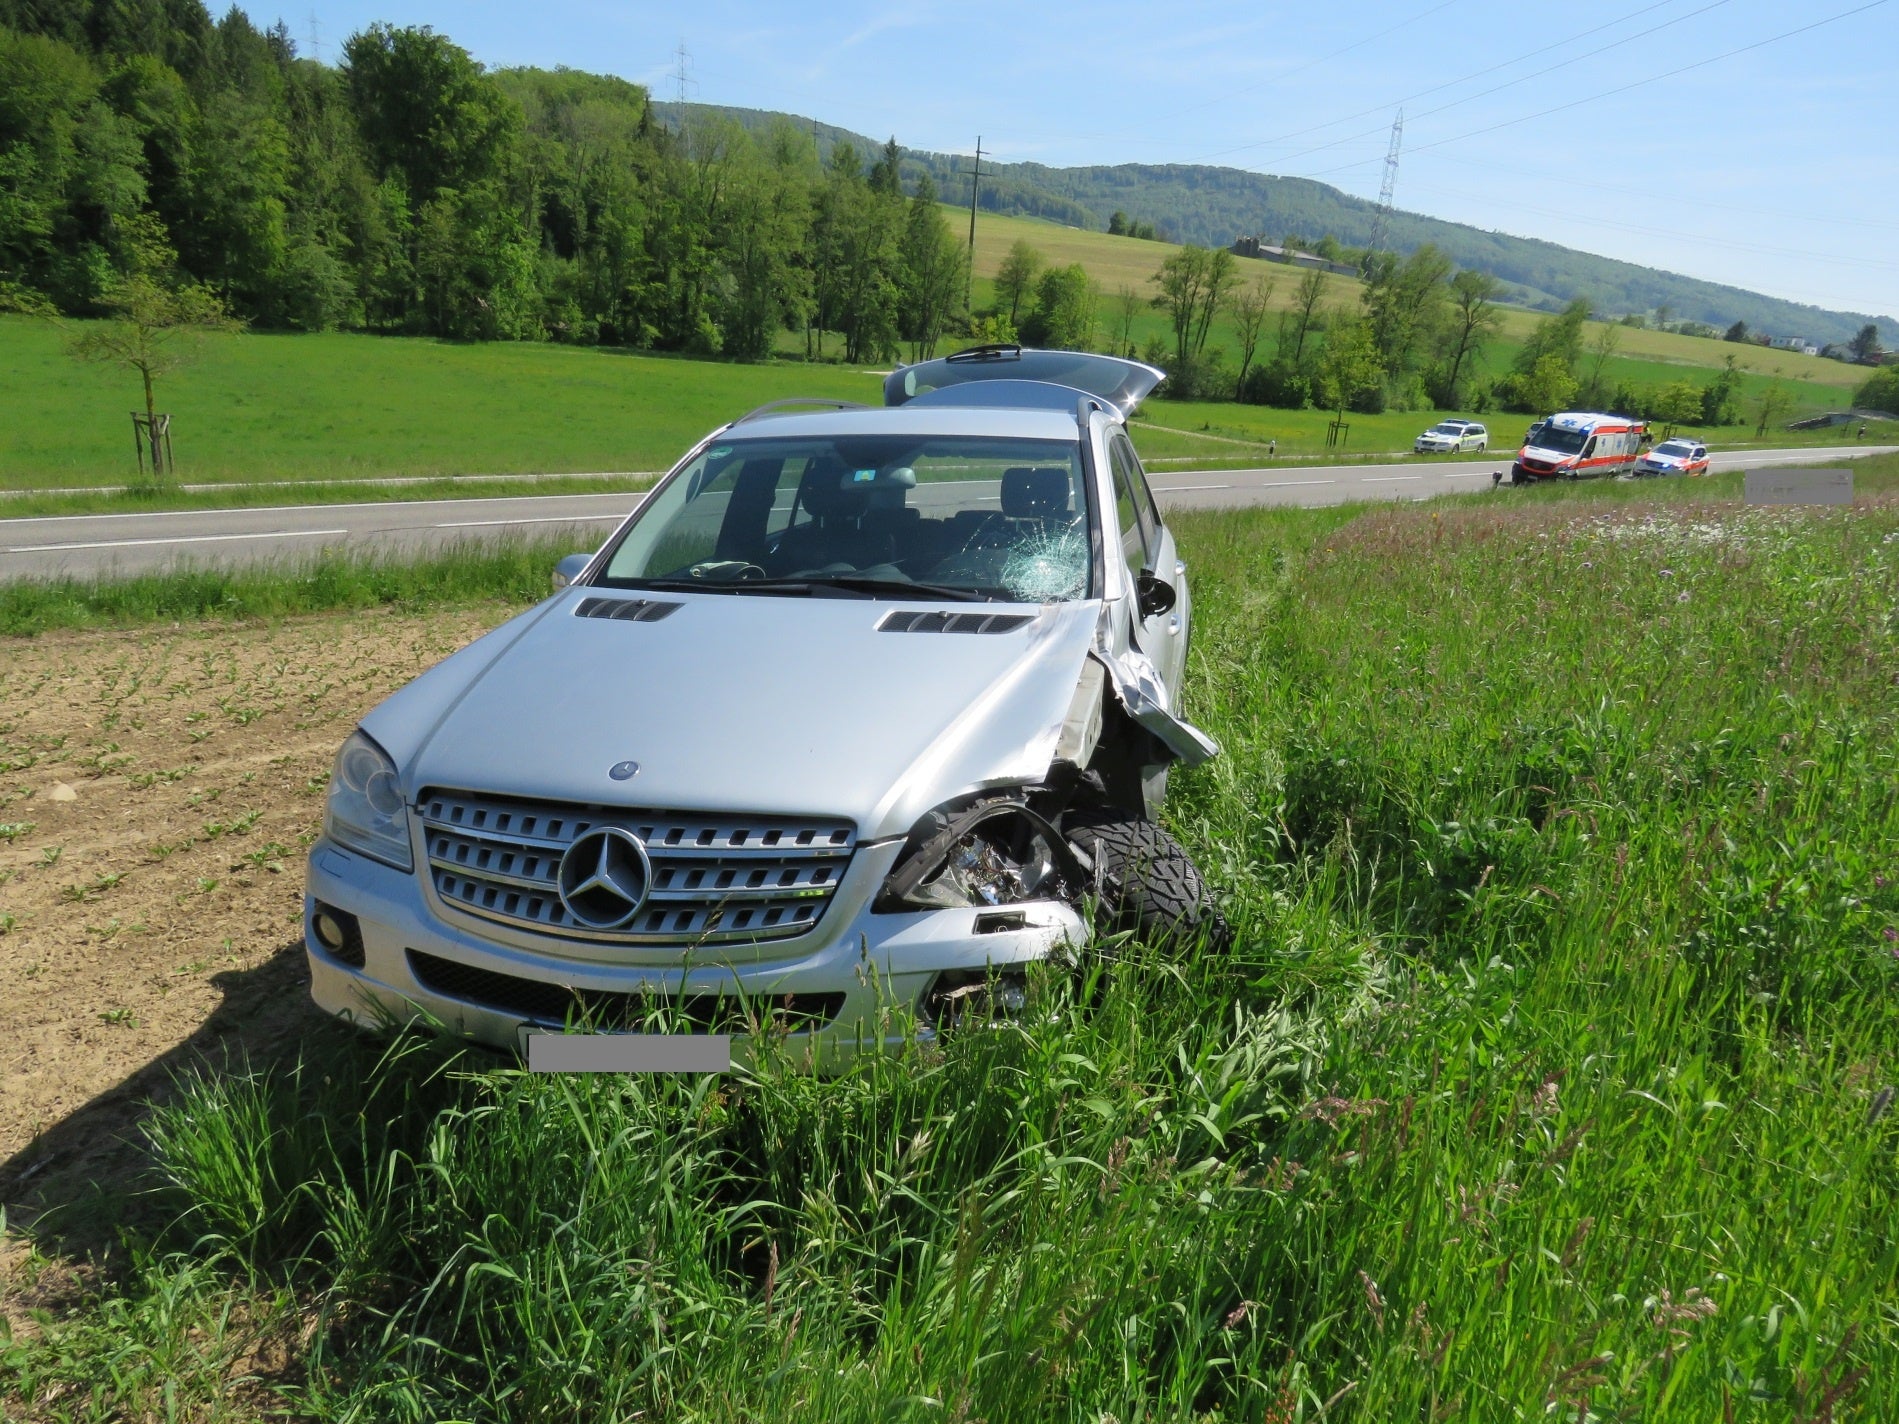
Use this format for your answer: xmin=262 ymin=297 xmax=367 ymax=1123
xmin=0 ymin=0 xmax=967 ymax=361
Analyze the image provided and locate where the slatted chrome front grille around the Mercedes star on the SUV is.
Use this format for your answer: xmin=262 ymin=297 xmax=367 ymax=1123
xmin=418 ymin=788 xmax=856 ymax=946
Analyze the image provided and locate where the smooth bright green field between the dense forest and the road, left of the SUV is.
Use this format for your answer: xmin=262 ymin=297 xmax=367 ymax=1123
xmin=0 ymin=317 xmax=881 ymax=488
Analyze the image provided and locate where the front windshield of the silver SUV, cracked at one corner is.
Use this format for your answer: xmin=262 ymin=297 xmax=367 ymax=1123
xmin=604 ymin=437 xmax=1092 ymax=602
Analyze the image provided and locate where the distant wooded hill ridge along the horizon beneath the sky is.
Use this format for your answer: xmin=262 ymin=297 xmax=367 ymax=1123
xmin=653 ymin=104 xmax=1899 ymax=347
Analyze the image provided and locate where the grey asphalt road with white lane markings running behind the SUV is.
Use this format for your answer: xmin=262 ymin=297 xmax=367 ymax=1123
xmin=0 ymin=446 xmax=1893 ymax=581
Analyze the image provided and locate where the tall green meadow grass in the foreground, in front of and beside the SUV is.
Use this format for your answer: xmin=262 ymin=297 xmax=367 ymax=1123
xmin=0 ymin=480 xmax=1899 ymax=1424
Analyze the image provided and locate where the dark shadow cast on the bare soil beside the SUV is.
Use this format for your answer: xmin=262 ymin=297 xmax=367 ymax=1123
xmin=0 ymin=940 xmax=361 ymax=1265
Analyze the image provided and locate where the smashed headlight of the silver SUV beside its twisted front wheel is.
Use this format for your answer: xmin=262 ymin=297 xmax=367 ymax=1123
xmin=875 ymin=797 xmax=1084 ymax=911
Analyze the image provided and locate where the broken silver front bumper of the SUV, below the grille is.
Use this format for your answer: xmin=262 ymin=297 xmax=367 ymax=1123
xmin=304 ymin=839 xmax=1086 ymax=1069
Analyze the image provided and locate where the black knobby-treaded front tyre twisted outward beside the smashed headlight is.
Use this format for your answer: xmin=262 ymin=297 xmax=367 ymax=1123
xmin=1062 ymin=811 xmax=1232 ymax=949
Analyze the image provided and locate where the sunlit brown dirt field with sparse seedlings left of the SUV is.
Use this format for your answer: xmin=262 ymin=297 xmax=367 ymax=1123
xmin=0 ymin=608 xmax=507 ymax=1213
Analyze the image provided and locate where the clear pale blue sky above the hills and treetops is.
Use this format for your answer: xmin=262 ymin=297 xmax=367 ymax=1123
xmin=296 ymin=0 xmax=1899 ymax=315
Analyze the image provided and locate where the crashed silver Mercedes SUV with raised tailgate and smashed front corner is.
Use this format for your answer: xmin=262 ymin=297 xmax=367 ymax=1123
xmin=304 ymin=347 xmax=1223 ymax=1063
